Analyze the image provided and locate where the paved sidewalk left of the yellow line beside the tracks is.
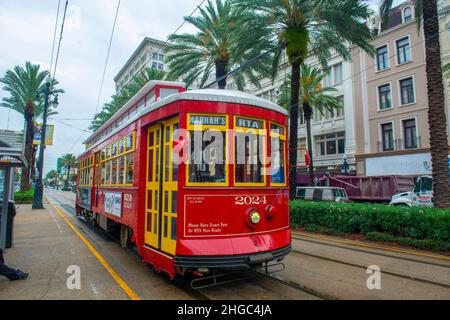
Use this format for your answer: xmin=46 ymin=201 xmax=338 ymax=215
xmin=0 ymin=202 xmax=128 ymax=299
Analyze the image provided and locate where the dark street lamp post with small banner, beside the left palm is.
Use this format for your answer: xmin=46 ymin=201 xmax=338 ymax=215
xmin=32 ymin=79 xmax=58 ymax=209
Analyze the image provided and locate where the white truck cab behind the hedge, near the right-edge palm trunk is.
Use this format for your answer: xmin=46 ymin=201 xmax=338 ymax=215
xmin=390 ymin=176 xmax=433 ymax=207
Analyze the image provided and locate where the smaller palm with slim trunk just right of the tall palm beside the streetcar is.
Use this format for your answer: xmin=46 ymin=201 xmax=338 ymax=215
xmin=277 ymin=64 xmax=343 ymax=185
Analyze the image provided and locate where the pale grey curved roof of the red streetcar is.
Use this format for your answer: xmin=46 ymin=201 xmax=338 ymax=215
xmin=80 ymin=87 xmax=288 ymax=156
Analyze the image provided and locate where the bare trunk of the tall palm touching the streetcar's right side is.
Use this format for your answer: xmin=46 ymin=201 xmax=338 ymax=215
xmin=289 ymin=62 xmax=300 ymax=199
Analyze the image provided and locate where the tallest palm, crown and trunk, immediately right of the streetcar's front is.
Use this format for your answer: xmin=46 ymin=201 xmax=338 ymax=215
xmin=234 ymin=0 xmax=374 ymax=199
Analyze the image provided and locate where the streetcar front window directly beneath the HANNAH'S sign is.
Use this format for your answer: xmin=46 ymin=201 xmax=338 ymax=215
xmin=189 ymin=130 xmax=226 ymax=183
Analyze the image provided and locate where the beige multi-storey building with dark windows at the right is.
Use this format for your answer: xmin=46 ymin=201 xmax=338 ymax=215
xmin=353 ymin=1 xmax=448 ymax=176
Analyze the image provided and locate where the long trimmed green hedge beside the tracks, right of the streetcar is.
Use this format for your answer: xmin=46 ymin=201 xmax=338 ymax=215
xmin=290 ymin=200 xmax=450 ymax=242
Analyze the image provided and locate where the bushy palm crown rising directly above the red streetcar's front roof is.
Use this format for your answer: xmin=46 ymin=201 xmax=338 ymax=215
xmin=165 ymin=0 xmax=274 ymax=90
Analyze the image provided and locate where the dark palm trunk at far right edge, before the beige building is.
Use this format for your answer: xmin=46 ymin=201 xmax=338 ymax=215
xmin=381 ymin=0 xmax=450 ymax=208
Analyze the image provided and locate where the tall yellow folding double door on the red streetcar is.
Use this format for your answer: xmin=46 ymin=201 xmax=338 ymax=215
xmin=145 ymin=118 xmax=178 ymax=255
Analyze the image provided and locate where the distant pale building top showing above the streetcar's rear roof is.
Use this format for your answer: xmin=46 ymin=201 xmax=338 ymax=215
xmin=114 ymin=37 xmax=167 ymax=92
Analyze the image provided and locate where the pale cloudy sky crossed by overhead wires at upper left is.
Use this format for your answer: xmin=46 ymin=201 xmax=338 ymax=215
xmin=0 ymin=0 xmax=400 ymax=173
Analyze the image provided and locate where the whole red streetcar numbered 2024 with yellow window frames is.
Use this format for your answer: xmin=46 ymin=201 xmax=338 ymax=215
xmin=76 ymin=81 xmax=291 ymax=278
